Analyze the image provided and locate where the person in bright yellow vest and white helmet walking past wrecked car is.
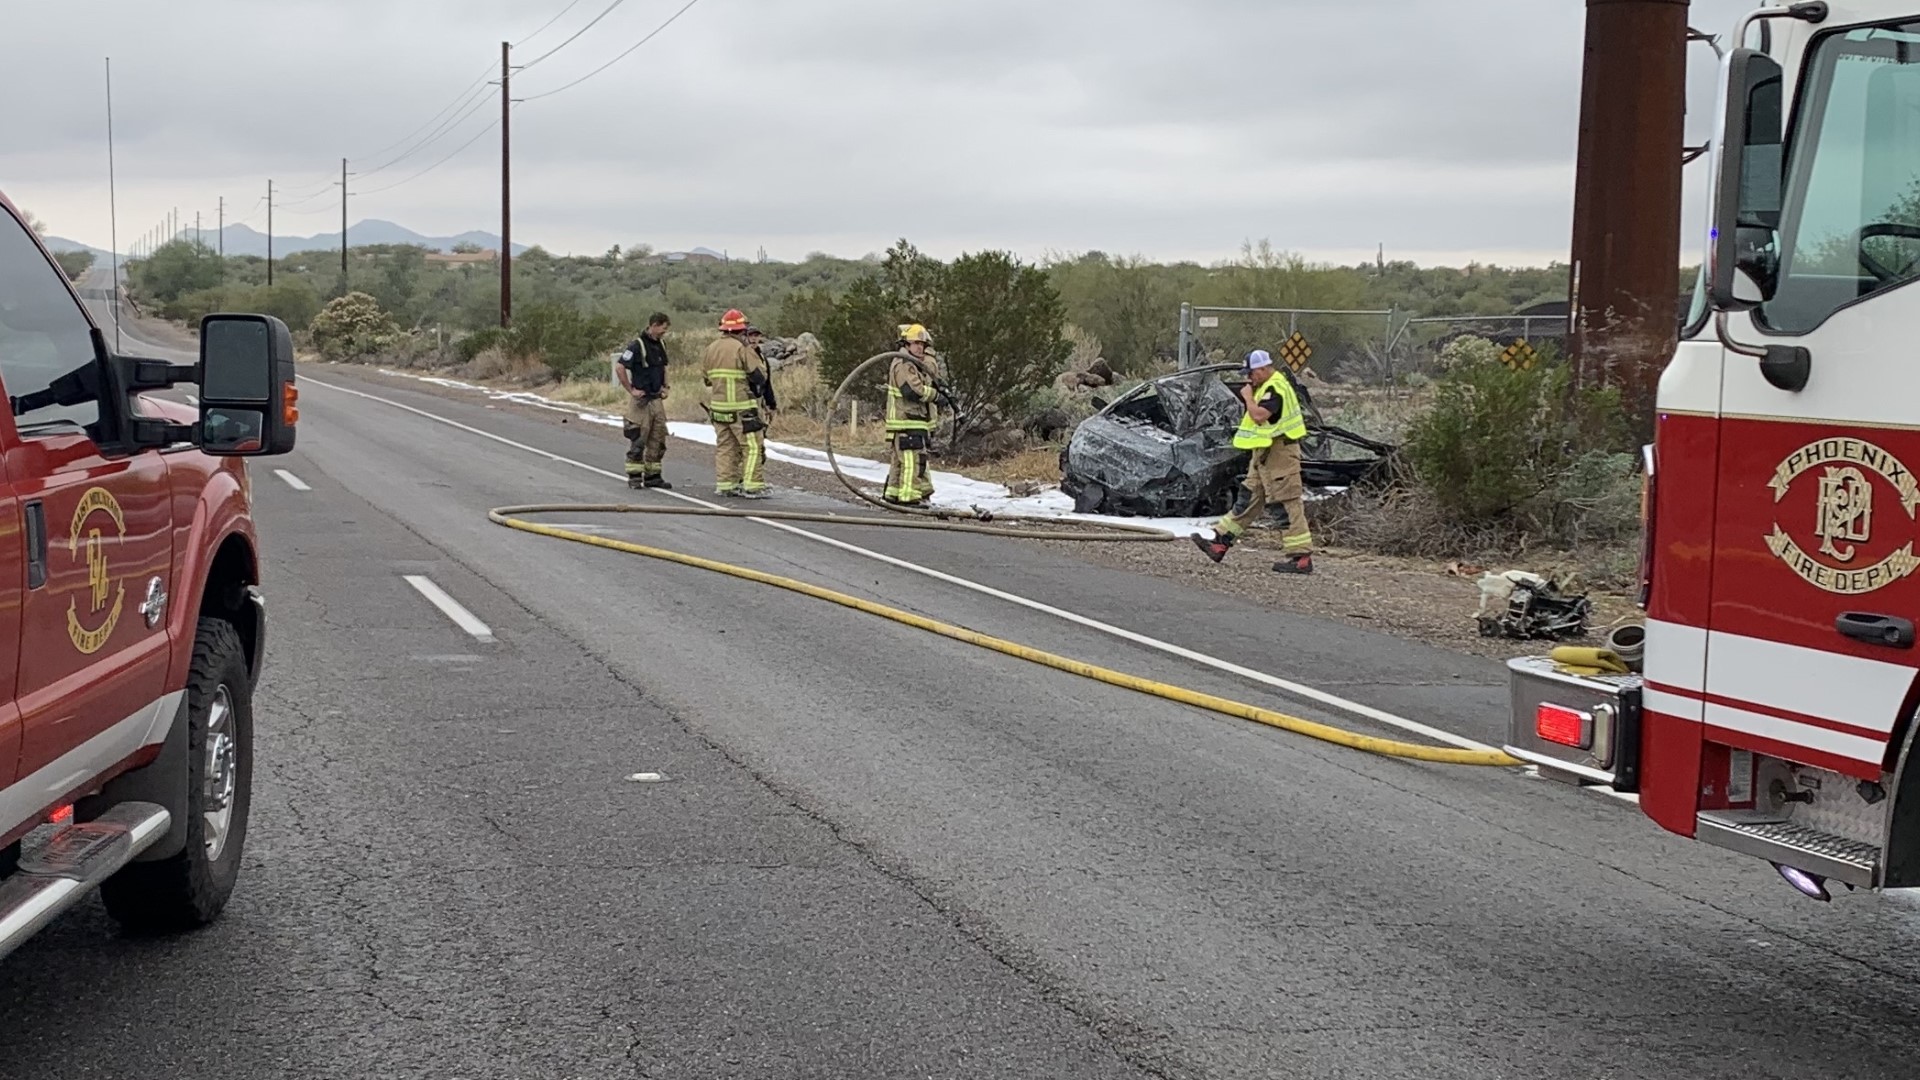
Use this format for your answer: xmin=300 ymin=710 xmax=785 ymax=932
xmin=1192 ymin=350 xmax=1313 ymax=575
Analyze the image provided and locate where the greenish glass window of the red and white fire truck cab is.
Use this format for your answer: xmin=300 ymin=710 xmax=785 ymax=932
xmin=1759 ymin=21 xmax=1920 ymax=332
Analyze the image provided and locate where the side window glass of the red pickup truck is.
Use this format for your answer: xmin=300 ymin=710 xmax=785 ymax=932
xmin=0 ymin=208 xmax=100 ymax=436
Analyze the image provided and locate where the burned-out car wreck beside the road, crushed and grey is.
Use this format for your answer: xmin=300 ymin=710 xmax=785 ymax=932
xmin=1060 ymin=365 xmax=1394 ymax=517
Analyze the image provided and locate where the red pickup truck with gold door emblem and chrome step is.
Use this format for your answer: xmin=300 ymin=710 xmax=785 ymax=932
xmin=0 ymin=196 xmax=298 ymax=957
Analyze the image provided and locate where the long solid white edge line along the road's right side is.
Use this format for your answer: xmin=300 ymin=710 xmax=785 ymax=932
xmin=305 ymin=377 xmax=1500 ymax=751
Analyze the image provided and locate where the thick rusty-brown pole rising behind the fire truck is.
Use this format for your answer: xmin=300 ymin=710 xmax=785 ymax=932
xmin=1567 ymin=0 xmax=1688 ymax=428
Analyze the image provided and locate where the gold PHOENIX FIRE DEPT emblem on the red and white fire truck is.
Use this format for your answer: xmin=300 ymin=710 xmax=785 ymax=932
xmin=1766 ymin=438 xmax=1920 ymax=596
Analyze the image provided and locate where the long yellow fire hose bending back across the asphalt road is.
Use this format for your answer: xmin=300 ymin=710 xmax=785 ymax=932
xmin=488 ymin=503 xmax=1524 ymax=767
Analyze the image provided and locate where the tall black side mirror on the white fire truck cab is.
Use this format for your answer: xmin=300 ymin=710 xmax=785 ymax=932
xmin=1707 ymin=48 xmax=1786 ymax=311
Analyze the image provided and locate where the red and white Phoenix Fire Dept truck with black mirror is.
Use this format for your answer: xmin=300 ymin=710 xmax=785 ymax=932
xmin=1507 ymin=0 xmax=1920 ymax=899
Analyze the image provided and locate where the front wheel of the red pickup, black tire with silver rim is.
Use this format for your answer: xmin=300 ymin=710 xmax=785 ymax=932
xmin=100 ymin=619 xmax=253 ymax=934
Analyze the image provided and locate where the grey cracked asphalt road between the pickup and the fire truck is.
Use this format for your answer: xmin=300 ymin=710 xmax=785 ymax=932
xmin=0 ymin=334 xmax=1920 ymax=1080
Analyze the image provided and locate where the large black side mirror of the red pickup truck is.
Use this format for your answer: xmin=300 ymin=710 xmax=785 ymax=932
xmin=196 ymin=313 xmax=300 ymax=457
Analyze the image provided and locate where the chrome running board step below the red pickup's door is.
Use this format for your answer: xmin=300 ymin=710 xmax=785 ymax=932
xmin=0 ymin=803 xmax=173 ymax=959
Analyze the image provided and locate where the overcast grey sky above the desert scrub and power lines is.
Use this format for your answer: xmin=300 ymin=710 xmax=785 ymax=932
xmin=0 ymin=0 xmax=1751 ymax=263
